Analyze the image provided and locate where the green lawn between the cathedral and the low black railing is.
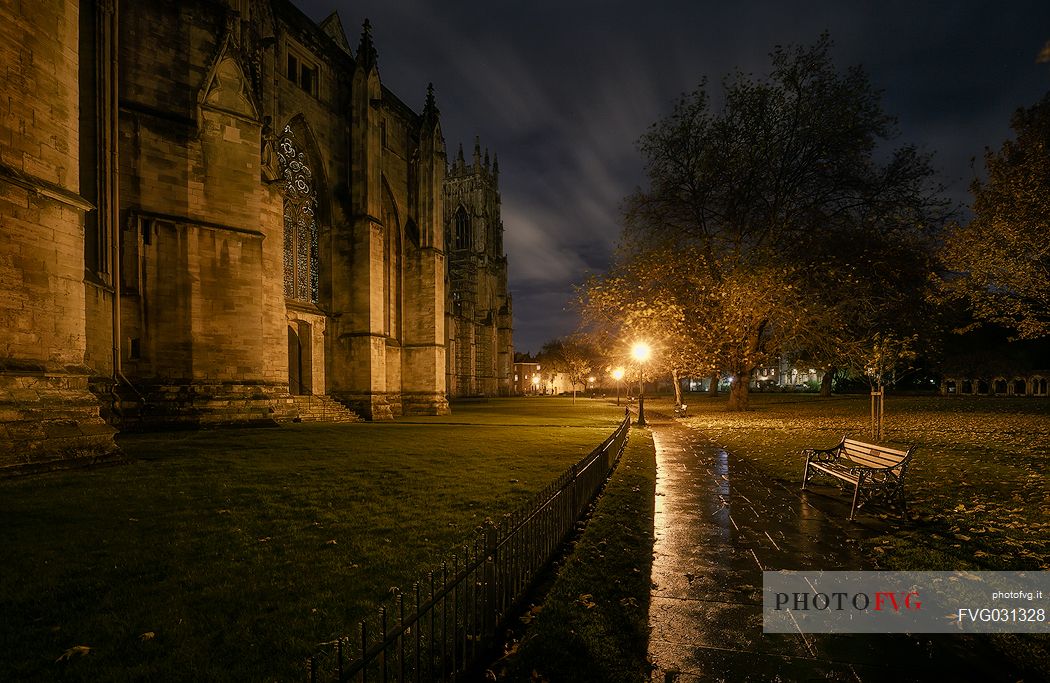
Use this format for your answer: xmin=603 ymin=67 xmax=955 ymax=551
xmin=0 ymin=398 xmax=621 ymax=681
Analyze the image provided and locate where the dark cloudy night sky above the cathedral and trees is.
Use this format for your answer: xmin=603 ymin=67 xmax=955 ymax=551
xmin=294 ymin=0 xmax=1050 ymax=352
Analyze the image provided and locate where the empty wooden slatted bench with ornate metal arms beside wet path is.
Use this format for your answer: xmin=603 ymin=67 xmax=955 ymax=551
xmin=802 ymin=436 xmax=915 ymax=519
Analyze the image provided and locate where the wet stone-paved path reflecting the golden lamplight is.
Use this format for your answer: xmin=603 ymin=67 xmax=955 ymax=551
xmin=649 ymin=415 xmax=1019 ymax=682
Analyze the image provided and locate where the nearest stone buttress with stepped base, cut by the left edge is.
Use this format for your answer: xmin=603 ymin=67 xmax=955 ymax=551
xmin=0 ymin=0 xmax=114 ymax=469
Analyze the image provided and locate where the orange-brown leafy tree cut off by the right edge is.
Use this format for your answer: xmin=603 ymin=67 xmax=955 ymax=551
xmin=942 ymin=92 xmax=1050 ymax=339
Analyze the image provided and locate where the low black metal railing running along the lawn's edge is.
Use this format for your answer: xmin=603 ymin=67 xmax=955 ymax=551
xmin=308 ymin=412 xmax=630 ymax=683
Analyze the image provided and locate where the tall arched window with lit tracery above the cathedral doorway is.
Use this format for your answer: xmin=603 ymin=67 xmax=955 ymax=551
xmin=277 ymin=126 xmax=320 ymax=303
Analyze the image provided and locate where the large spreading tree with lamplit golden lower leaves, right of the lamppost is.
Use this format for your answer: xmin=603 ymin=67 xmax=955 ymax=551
xmin=621 ymin=36 xmax=943 ymax=410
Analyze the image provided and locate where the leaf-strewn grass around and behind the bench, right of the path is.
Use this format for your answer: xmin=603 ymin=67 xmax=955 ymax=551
xmin=686 ymin=395 xmax=1050 ymax=570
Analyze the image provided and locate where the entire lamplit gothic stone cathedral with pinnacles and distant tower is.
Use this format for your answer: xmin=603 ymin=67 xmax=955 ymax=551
xmin=0 ymin=0 xmax=513 ymax=469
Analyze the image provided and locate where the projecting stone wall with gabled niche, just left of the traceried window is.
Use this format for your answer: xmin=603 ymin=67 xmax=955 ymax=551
xmin=120 ymin=2 xmax=291 ymax=423
